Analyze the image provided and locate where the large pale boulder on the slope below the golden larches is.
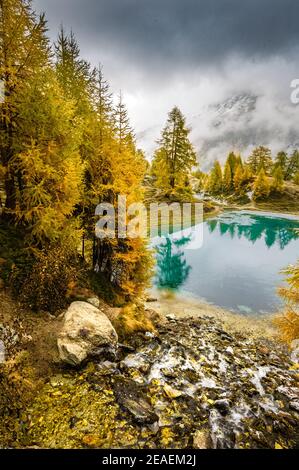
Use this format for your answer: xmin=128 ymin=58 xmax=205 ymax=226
xmin=57 ymin=302 xmax=118 ymax=366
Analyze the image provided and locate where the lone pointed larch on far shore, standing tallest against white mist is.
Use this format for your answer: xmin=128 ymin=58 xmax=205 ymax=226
xmin=152 ymin=107 xmax=196 ymax=193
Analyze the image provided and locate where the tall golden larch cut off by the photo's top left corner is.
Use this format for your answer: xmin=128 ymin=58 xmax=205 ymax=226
xmin=0 ymin=0 xmax=49 ymax=215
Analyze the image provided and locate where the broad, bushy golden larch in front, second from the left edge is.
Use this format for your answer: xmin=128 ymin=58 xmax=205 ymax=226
xmin=14 ymin=68 xmax=83 ymax=248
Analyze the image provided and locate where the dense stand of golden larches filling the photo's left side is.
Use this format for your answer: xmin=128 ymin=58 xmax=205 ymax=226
xmin=0 ymin=0 xmax=152 ymax=311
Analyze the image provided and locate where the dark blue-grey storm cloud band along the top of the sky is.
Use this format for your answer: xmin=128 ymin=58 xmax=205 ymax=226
xmin=35 ymin=0 xmax=299 ymax=67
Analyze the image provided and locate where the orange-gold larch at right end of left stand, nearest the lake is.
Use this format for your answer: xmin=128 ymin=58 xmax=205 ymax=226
xmin=93 ymin=94 xmax=152 ymax=301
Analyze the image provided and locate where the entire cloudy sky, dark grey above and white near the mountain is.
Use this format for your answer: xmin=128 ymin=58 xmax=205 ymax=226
xmin=33 ymin=0 xmax=299 ymax=165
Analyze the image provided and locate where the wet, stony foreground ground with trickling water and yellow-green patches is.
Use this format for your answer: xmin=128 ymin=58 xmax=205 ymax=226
xmin=0 ymin=294 xmax=299 ymax=449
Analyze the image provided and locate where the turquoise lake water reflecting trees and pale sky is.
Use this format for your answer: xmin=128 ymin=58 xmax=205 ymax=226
xmin=153 ymin=211 xmax=299 ymax=314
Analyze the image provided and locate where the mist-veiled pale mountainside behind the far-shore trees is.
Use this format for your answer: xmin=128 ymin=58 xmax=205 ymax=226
xmin=137 ymin=93 xmax=299 ymax=170
